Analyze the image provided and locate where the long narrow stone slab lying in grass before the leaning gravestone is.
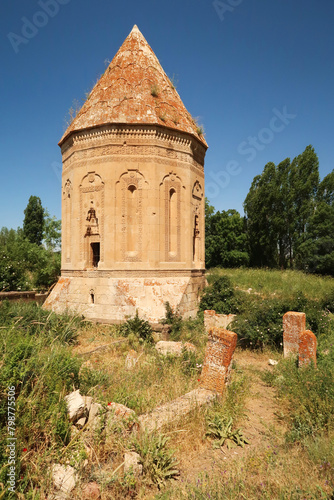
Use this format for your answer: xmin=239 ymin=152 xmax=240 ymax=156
xmin=138 ymin=387 xmax=217 ymax=432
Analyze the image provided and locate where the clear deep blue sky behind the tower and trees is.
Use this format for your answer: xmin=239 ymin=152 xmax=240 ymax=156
xmin=0 ymin=0 xmax=334 ymax=228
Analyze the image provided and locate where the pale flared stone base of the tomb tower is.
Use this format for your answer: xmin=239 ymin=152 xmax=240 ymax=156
xmin=43 ymin=270 xmax=205 ymax=323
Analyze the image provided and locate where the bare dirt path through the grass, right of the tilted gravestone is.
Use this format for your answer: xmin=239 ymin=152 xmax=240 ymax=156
xmin=181 ymin=351 xmax=286 ymax=481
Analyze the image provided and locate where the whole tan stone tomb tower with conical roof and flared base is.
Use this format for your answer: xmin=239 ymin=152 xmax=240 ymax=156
xmin=44 ymin=26 xmax=207 ymax=323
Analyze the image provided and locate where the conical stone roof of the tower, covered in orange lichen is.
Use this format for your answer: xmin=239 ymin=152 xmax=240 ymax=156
xmin=59 ymin=26 xmax=207 ymax=146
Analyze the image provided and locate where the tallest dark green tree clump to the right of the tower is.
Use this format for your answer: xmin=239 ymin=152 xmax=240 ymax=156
xmin=244 ymin=146 xmax=320 ymax=268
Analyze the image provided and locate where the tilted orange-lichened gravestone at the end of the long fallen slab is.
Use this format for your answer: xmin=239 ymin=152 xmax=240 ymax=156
xmin=200 ymin=328 xmax=237 ymax=394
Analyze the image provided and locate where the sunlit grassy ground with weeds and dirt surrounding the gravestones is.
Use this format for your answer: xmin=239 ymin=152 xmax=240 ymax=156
xmin=0 ymin=270 xmax=334 ymax=500
